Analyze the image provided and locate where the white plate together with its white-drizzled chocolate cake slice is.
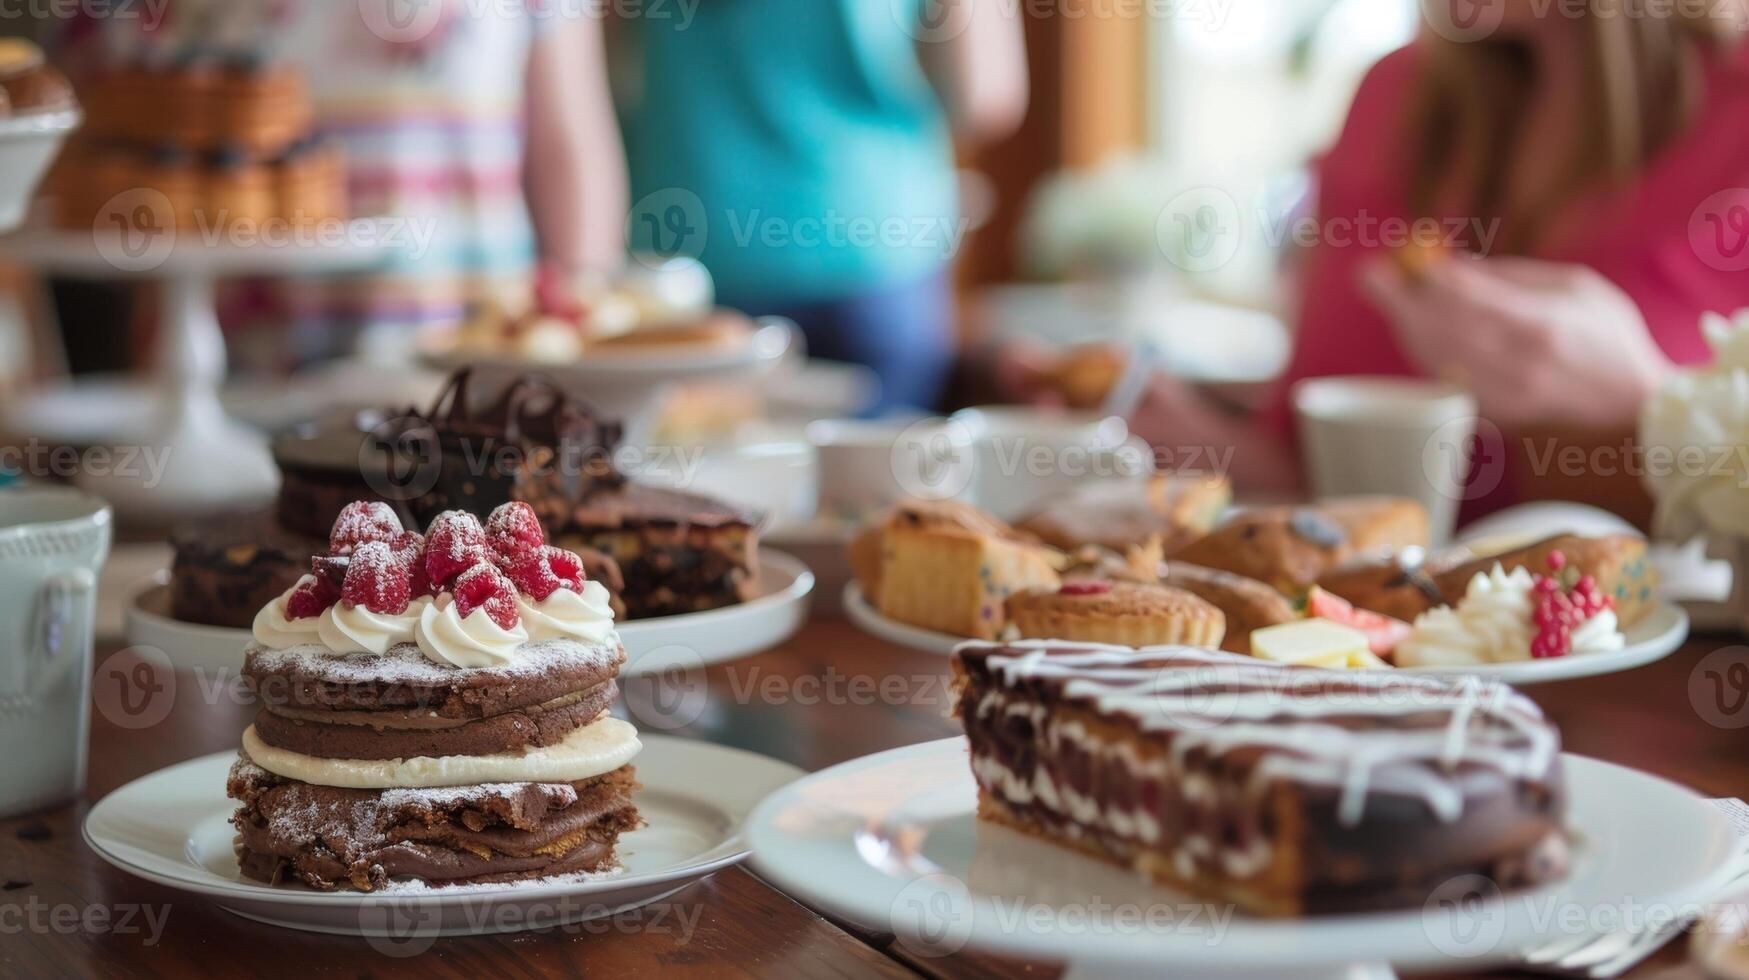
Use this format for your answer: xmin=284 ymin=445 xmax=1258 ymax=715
xmin=747 ymin=641 xmax=1737 ymax=978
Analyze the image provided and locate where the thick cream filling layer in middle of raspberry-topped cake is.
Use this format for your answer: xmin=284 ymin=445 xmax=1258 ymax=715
xmin=243 ymin=718 xmax=642 ymax=789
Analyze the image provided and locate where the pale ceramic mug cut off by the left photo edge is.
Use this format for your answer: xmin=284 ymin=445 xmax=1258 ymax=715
xmin=0 ymin=488 xmax=110 ymax=817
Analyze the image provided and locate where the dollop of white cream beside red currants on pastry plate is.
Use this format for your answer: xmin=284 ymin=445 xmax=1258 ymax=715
xmin=1396 ymin=565 xmax=1536 ymax=667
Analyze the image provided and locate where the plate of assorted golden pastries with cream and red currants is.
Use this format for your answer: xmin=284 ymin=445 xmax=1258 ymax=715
xmin=845 ymin=486 xmax=1688 ymax=684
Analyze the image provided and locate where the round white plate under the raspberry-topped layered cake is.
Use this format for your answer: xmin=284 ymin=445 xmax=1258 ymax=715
xmin=84 ymin=733 xmax=803 ymax=942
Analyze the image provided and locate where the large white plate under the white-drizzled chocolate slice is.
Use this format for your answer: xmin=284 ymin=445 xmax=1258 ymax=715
xmin=747 ymin=739 xmax=1739 ymax=977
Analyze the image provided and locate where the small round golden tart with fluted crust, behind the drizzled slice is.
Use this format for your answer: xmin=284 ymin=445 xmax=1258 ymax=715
xmin=1007 ymin=581 xmax=1226 ymax=649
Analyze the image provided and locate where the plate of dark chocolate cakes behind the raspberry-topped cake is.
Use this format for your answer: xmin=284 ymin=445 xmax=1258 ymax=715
xmin=126 ymin=369 xmax=813 ymax=676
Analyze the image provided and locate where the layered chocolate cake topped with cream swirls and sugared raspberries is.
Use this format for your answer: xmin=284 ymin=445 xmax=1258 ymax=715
xmin=227 ymin=502 xmax=640 ymax=891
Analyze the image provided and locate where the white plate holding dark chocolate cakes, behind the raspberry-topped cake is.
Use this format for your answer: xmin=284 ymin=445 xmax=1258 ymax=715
xmin=122 ymin=548 xmax=813 ymax=677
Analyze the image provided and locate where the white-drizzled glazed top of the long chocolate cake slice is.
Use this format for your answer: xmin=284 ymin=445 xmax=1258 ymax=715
xmin=962 ymin=641 xmax=1558 ymax=831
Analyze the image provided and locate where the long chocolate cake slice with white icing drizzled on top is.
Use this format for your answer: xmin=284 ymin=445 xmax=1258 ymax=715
xmin=953 ymin=641 xmax=1567 ymax=915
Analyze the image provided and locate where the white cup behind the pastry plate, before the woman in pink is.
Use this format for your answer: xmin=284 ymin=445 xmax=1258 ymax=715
xmin=1293 ymin=378 xmax=1476 ymax=544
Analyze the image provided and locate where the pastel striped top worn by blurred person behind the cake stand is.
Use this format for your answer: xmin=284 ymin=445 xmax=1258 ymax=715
xmin=276 ymin=0 xmax=537 ymax=351
